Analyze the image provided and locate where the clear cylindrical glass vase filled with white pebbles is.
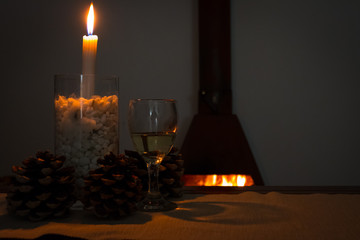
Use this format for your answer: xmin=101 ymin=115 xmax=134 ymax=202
xmin=55 ymin=74 xmax=119 ymax=185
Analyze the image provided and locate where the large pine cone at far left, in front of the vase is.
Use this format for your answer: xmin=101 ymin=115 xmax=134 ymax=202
xmin=6 ymin=151 xmax=76 ymax=221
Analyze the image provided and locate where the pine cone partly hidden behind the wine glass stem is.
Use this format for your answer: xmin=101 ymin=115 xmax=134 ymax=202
xmin=125 ymin=148 xmax=184 ymax=198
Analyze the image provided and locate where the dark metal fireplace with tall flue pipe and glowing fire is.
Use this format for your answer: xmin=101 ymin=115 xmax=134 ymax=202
xmin=181 ymin=0 xmax=264 ymax=186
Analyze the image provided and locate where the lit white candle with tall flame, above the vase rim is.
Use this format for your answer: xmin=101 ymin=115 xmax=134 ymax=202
xmin=82 ymin=3 xmax=98 ymax=74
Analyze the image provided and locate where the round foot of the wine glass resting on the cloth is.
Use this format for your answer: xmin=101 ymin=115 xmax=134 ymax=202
xmin=137 ymin=197 xmax=177 ymax=212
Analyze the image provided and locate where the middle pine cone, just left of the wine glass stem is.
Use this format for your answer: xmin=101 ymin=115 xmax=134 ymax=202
xmin=82 ymin=153 xmax=142 ymax=218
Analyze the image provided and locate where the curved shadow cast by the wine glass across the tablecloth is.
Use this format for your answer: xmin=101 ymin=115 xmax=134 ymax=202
xmin=164 ymin=202 xmax=290 ymax=225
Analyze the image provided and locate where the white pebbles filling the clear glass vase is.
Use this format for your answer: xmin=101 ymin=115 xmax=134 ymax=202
xmin=55 ymin=95 xmax=119 ymax=182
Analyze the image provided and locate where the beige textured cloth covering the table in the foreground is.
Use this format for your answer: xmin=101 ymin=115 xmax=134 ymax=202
xmin=0 ymin=192 xmax=360 ymax=240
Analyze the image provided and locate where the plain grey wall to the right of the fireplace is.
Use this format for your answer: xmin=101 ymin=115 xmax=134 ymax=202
xmin=232 ymin=0 xmax=360 ymax=185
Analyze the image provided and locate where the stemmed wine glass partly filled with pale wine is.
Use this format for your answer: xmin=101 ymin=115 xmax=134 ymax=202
xmin=128 ymin=99 xmax=177 ymax=212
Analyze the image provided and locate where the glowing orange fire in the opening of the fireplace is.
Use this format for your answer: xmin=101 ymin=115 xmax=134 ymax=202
xmin=183 ymin=174 xmax=254 ymax=187
